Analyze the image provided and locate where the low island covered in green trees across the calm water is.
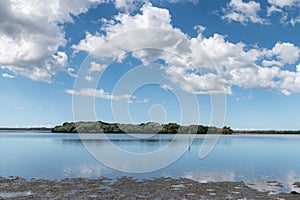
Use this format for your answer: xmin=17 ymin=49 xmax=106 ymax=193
xmin=51 ymin=121 xmax=233 ymax=134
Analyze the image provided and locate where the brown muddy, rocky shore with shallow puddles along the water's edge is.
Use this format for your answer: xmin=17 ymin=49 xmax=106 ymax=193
xmin=0 ymin=177 xmax=300 ymax=200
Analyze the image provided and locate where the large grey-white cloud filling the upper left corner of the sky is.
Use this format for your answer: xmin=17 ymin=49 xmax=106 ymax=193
xmin=0 ymin=0 xmax=106 ymax=82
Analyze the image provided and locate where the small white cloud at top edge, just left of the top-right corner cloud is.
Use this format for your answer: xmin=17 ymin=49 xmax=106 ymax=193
xmin=222 ymin=0 xmax=267 ymax=24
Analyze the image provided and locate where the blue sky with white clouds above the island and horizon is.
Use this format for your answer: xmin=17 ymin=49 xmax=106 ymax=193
xmin=0 ymin=0 xmax=300 ymax=130
